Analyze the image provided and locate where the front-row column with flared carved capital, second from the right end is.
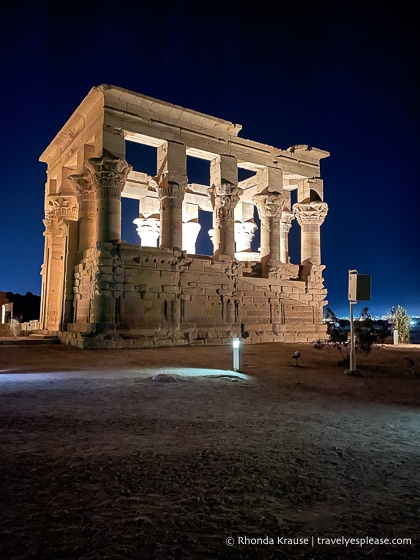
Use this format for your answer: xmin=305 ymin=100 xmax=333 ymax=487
xmin=252 ymin=191 xmax=284 ymax=276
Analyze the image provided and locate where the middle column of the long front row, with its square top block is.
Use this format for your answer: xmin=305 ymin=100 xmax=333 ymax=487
xmin=208 ymin=156 xmax=243 ymax=257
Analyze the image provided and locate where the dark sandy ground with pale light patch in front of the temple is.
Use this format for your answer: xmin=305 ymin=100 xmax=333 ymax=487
xmin=0 ymin=344 xmax=420 ymax=560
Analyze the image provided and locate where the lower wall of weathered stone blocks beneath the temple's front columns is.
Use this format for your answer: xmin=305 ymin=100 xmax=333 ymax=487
xmin=60 ymin=243 xmax=326 ymax=348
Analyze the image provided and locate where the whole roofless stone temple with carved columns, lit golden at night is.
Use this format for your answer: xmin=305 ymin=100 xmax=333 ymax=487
xmin=40 ymin=85 xmax=329 ymax=348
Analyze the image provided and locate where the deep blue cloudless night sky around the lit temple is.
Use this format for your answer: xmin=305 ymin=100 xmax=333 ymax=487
xmin=0 ymin=0 xmax=420 ymax=315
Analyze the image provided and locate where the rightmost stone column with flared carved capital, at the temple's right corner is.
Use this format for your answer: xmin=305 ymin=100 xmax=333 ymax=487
xmin=293 ymin=201 xmax=328 ymax=264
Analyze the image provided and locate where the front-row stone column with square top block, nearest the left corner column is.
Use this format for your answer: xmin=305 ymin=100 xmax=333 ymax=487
xmin=156 ymin=141 xmax=187 ymax=249
